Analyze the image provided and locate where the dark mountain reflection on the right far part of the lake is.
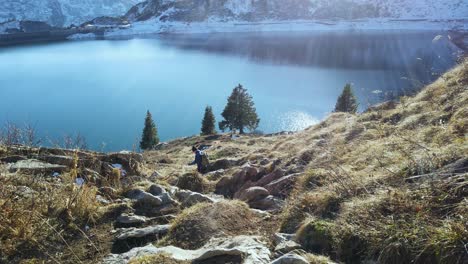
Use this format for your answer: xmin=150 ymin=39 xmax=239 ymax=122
xmin=162 ymin=31 xmax=461 ymax=96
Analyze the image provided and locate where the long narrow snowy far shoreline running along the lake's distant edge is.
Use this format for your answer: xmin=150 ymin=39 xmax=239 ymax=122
xmin=0 ymin=19 xmax=468 ymax=49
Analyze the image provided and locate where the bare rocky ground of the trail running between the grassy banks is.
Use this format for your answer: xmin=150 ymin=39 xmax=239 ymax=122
xmin=1 ymin=142 xmax=322 ymax=264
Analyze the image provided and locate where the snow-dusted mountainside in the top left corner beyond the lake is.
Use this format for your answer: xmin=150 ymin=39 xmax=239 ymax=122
xmin=0 ymin=0 xmax=141 ymax=27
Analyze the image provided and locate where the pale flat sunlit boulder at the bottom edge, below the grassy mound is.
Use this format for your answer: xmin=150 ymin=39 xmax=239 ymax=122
xmin=102 ymin=236 xmax=270 ymax=264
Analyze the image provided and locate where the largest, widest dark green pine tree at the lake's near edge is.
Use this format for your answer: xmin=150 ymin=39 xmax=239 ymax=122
xmin=219 ymin=84 xmax=260 ymax=134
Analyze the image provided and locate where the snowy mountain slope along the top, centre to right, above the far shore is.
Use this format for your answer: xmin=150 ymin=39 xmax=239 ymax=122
xmin=126 ymin=0 xmax=468 ymax=22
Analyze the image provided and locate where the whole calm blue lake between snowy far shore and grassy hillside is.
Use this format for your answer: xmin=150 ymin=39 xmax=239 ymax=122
xmin=0 ymin=32 xmax=457 ymax=151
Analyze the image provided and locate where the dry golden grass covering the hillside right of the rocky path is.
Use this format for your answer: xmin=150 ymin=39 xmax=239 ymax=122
xmin=281 ymin=61 xmax=468 ymax=263
